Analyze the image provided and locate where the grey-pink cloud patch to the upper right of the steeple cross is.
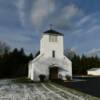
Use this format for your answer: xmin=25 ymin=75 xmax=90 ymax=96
xmin=51 ymin=4 xmax=83 ymax=30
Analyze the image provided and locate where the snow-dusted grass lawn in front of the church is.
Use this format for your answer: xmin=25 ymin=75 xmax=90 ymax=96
xmin=0 ymin=80 xmax=99 ymax=100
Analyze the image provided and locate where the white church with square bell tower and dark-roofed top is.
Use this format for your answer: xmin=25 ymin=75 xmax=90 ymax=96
xmin=28 ymin=29 xmax=72 ymax=81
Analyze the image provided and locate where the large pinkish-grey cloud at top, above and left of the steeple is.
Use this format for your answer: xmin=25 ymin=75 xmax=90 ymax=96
xmin=31 ymin=0 xmax=55 ymax=27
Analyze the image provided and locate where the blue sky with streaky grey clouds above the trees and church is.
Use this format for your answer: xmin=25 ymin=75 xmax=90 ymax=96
xmin=0 ymin=0 xmax=100 ymax=54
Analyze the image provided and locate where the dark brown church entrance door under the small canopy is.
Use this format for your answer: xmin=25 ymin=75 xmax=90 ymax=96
xmin=49 ymin=67 xmax=58 ymax=80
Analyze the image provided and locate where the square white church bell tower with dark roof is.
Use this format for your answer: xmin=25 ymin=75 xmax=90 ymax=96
xmin=40 ymin=29 xmax=64 ymax=58
